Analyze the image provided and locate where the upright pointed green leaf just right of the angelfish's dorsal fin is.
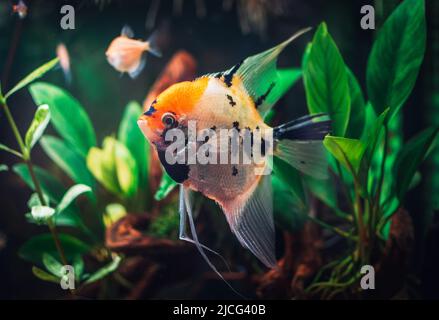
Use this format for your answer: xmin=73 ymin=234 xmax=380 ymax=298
xmin=303 ymin=23 xmax=351 ymax=136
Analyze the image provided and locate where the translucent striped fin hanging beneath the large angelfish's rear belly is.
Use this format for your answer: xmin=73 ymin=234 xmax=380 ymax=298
xmin=223 ymin=175 xmax=276 ymax=268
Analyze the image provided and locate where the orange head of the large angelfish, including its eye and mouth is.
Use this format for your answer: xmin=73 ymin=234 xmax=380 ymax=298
xmin=137 ymin=78 xmax=208 ymax=151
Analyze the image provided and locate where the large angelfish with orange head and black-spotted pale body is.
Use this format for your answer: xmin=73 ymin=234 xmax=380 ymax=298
xmin=138 ymin=28 xmax=330 ymax=282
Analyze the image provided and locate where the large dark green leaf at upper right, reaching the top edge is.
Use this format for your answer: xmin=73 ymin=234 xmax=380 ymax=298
xmin=367 ymin=0 xmax=426 ymax=118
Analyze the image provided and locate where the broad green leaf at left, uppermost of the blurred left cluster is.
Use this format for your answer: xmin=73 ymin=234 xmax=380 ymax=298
xmin=30 ymin=82 xmax=96 ymax=157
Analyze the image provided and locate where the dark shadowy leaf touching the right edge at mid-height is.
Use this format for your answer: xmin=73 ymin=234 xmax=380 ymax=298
xmin=393 ymin=127 xmax=439 ymax=201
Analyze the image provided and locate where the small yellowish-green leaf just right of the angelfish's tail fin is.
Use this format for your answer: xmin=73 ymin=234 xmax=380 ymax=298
xmin=323 ymin=136 xmax=366 ymax=173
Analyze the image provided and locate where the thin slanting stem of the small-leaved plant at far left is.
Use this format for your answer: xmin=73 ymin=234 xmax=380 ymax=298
xmin=2 ymin=101 xmax=67 ymax=265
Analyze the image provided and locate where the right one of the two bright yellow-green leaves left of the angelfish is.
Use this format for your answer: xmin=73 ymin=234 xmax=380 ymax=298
xmin=114 ymin=141 xmax=138 ymax=197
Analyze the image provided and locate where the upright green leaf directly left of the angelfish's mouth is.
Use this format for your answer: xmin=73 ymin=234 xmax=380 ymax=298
xmin=118 ymin=101 xmax=150 ymax=192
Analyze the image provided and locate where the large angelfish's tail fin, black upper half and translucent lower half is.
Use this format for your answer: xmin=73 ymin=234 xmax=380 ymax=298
xmin=273 ymin=113 xmax=331 ymax=179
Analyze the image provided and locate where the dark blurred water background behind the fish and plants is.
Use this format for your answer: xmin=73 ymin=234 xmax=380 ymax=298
xmin=0 ymin=0 xmax=439 ymax=299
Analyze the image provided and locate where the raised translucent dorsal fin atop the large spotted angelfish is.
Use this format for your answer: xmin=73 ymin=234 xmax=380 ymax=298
xmin=207 ymin=28 xmax=311 ymax=116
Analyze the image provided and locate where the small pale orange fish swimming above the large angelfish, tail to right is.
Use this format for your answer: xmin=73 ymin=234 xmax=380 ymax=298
xmin=105 ymin=26 xmax=161 ymax=78
